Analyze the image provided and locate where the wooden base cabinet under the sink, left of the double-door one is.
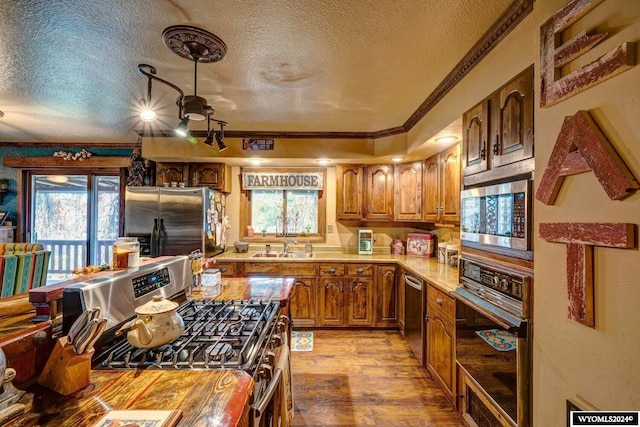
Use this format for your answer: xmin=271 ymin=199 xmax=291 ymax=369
xmin=282 ymin=263 xmax=317 ymax=328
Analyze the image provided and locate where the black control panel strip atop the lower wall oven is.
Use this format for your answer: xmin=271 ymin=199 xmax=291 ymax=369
xmin=462 ymin=260 xmax=528 ymax=301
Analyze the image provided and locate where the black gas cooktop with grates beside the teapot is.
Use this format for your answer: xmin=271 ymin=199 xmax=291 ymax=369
xmin=94 ymin=300 xmax=283 ymax=375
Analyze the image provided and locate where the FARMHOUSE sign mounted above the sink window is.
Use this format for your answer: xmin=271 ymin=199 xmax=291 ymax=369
xmin=242 ymin=172 xmax=323 ymax=190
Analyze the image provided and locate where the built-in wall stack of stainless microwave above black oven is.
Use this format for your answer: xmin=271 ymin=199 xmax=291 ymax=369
xmin=455 ymin=178 xmax=533 ymax=427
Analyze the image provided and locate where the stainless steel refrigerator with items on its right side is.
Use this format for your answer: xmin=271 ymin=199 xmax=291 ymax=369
xmin=124 ymin=187 xmax=226 ymax=257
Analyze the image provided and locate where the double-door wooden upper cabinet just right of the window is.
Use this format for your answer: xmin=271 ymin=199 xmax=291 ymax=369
xmin=336 ymin=165 xmax=394 ymax=221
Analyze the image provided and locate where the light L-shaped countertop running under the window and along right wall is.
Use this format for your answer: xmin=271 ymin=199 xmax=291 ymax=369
xmin=211 ymin=252 xmax=459 ymax=293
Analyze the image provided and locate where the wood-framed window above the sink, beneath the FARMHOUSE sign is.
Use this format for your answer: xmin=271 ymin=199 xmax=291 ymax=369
xmin=241 ymin=169 xmax=325 ymax=241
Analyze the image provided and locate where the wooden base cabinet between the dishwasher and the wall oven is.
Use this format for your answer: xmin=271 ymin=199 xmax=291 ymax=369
xmin=426 ymin=284 xmax=456 ymax=405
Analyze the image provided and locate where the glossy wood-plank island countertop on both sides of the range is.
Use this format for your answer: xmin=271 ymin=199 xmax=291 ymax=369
xmin=8 ymin=277 xmax=293 ymax=427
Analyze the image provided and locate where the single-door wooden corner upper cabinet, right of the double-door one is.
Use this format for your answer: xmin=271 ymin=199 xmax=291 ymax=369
xmin=393 ymin=161 xmax=422 ymax=221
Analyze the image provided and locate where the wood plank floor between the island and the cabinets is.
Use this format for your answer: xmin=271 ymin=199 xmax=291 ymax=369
xmin=291 ymin=330 xmax=463 ymax=427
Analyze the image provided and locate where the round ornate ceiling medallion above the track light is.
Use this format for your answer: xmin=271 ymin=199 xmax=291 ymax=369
xmin=162 ymin=25 xmax=227 ymax=63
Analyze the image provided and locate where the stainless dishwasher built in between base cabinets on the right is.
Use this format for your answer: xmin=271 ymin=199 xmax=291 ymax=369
xmin=404 ymin=273 xmax=425 ymax=366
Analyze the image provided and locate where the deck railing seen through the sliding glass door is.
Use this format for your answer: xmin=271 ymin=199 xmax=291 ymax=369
xmin=38 ymin=240 xmax=114 ymax=274
